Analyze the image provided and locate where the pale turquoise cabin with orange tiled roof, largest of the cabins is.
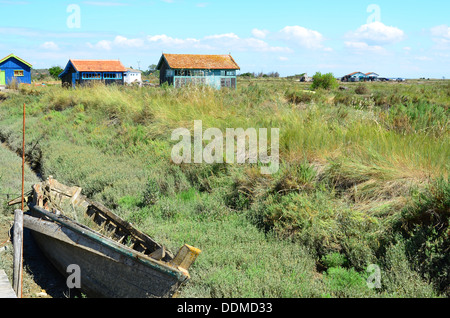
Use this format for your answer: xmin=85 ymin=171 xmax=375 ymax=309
xmin=157 ymin=54 xmax=240 ymax=89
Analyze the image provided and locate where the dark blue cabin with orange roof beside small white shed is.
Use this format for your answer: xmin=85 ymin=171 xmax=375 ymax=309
xmin=59 ymin=60 xmax=127 ymax=87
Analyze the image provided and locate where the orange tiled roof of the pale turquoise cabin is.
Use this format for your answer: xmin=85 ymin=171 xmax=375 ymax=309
xmin=163 ymin=54 xmax=240 ymax=70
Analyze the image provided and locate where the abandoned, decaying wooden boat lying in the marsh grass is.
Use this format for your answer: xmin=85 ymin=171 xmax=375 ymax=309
xmin=24 ymin=177 xmax=200 ymax=298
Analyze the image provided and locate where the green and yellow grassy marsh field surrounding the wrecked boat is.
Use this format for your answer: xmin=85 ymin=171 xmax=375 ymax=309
xmin=0 ymin=79 xmax=450 ymax=298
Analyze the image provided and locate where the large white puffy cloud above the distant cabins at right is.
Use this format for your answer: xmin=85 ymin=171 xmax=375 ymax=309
xmin=347 ymin=21 xmax=405 ymax=45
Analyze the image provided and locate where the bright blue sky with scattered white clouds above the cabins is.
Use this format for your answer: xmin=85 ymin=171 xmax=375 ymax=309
xmin=0 ymin=0 xmax=450 ymax=78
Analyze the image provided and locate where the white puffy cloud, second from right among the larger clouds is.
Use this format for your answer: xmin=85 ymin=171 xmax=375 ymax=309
xmin=279 ymin=25 xmax=325 ymax=49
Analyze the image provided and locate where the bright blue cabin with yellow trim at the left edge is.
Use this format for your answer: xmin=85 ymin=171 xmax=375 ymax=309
xmin=0 ymin=54 xmax=33 ymax=85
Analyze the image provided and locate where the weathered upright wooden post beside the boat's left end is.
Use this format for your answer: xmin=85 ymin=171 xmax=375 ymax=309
xmin=13 ymin=210 xmax=23 ymax=298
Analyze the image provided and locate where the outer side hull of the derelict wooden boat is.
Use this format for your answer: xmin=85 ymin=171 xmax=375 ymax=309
xmin=24 ymin=215 xmax=187 ymax=298
